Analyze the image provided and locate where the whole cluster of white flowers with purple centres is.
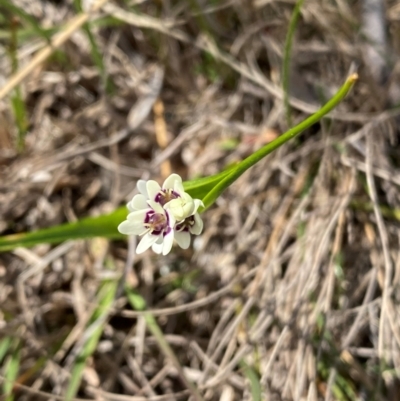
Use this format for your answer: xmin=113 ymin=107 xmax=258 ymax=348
xmin=118 ymin=174 xmax=203 ymax=255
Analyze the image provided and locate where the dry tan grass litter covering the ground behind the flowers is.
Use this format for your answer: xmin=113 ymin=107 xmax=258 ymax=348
xmin=0 ymin=0 xmax=400 ymax=401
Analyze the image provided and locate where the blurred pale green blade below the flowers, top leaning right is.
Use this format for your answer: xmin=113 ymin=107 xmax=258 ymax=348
xmin=65 ymin=274 xmax=118 ymax=401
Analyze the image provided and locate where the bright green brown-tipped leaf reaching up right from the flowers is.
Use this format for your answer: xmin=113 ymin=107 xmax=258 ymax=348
xmin=203 ymin=74 xmax=358 ymax=210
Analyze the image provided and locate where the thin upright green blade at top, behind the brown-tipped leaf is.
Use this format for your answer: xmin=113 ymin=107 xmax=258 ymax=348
xmin=282 ymin=0 xmax=304 ymax=127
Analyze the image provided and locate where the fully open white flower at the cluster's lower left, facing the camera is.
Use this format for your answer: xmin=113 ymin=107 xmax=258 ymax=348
xmin=118 ymin=200 xmax=175 ymax=255
